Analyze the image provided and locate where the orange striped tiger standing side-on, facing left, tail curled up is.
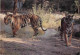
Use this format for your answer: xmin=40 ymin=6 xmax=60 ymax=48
xmin=4 ymin=14 xmax=47 ymax=37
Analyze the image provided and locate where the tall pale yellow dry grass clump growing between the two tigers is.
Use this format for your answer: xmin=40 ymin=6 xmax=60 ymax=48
xmin=30 ymin=5 xmax=64 ymax=28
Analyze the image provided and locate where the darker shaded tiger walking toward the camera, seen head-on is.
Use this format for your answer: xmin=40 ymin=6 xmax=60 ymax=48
xmin=59 ymin=15 xmax=74 ymax=46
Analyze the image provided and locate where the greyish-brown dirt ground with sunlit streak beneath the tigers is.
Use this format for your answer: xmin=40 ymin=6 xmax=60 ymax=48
xmin=0 ymin=28 xmax=80 ymax=55
